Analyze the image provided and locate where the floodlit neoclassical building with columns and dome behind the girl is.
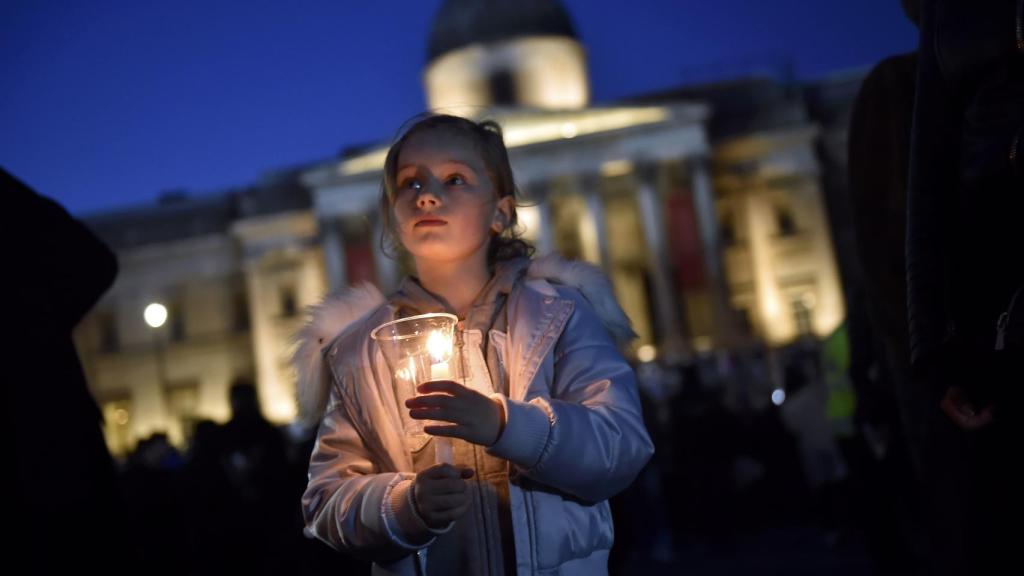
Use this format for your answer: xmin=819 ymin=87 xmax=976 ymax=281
xmin=76 ymin=0 xmax=852 ymax=453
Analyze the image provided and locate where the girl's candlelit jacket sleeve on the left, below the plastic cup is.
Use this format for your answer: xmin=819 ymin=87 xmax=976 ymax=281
xmin=302 ymin=366 xmax=451 ymax=564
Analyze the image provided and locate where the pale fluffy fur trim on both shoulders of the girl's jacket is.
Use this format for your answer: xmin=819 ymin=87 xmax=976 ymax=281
xmin=292 ymin=254 xmax=637 ymax=424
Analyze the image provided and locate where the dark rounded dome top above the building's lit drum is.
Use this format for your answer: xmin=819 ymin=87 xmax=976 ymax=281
xmin=427 ymin=0 xmax=577 ymax=61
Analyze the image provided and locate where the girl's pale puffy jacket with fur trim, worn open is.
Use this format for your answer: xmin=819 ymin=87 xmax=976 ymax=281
xmin=295 ymin=256 xmax=653 ymax=575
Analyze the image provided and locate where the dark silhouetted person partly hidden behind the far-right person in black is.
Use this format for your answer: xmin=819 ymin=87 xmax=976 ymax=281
xmin=847 ymin=0 xmax=928 ymax=570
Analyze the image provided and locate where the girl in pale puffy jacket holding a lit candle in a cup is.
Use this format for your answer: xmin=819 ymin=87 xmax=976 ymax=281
xmin=295 ymin=116 xmax=653 ymax=575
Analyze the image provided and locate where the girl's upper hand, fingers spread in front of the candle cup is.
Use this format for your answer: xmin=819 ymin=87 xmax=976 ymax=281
xmin=406 ymin=380 xmax=505 ymax=446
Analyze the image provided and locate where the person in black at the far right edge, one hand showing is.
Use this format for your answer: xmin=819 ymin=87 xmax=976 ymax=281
xmin=906 ymin=0 xmax=1024 ymax=574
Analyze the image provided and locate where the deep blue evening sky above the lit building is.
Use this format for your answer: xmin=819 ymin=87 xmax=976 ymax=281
xmin=0 ymin=0 xmax=916 ymax=214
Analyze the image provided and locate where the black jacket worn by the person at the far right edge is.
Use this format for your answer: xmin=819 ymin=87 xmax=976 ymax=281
xmin=906 ymin=0 xmax=1024 ymax=404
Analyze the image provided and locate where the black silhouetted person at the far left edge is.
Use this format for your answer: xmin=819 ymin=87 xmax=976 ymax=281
xmin=0 ymin=165 xmax=132 ymax=574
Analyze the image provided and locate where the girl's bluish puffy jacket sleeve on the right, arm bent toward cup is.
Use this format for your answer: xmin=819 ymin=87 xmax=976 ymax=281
xmin=488 ymin=290 xmax=654 ymax=502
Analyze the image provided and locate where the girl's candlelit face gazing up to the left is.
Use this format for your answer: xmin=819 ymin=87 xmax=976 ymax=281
xmin=393 ymin=129 xmax=513 ymax=265
